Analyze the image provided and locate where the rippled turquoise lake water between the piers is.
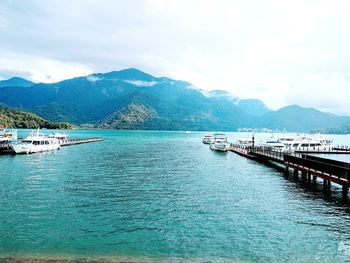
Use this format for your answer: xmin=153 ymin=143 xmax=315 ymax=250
xmin=0 ymin=131 xmax=350 ymax=262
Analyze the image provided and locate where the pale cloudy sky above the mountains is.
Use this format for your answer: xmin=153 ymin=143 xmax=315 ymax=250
xmin=0 ymin=0 xmax=350 ymax=115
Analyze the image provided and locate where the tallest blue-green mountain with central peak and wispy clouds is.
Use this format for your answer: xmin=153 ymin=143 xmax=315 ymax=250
xmin=0 ymin=68 xmax=254 ymax=130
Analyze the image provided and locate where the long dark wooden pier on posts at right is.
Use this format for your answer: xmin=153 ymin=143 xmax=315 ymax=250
xmin=229 ymin=144 xmax=350 ymax=198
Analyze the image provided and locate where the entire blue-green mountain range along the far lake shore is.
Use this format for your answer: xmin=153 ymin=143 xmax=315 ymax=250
xmin=0 ymin=68 xmax=350 ymax=132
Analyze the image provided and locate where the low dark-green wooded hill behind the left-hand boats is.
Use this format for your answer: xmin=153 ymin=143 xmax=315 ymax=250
xmin=0 ymin=105 xmax=74 ymax=129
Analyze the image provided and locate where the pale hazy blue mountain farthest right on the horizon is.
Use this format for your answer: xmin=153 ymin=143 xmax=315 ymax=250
xmin=260 ymin=105 xmax=350 ymax=132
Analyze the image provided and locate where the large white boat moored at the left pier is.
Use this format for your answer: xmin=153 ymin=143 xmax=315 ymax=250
xmin=11 ymin=129 xmax=60 ymax=154
